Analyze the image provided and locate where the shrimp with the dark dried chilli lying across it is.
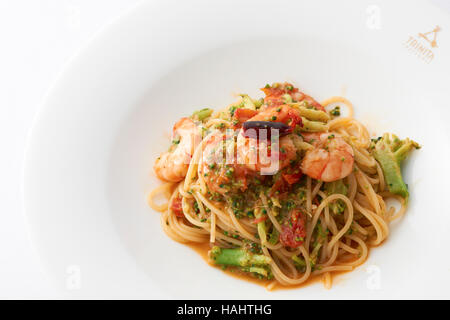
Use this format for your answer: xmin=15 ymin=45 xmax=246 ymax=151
xmin=237 ymin=105 xmax=301 ymax=174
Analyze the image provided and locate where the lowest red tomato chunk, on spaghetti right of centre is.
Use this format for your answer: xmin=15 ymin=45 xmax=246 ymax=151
xmin=280 ymin=209 xmax=306 ymax=248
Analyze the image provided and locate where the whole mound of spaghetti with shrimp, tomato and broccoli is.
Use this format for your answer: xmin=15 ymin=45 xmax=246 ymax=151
xmin=149 ymin=83 xmax=420 ymax=289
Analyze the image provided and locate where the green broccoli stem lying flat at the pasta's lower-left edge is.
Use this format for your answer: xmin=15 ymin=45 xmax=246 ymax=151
xmin=210 ymin=246 xmax=271 ymax=269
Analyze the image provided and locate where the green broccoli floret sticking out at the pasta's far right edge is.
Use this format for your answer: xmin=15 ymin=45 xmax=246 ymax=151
xmin=371 ymin=133 xmax=420 ymax=200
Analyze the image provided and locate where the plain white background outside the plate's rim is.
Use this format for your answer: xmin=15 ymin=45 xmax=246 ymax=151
xmin=0 ymin=0 xmax=450 ymax=299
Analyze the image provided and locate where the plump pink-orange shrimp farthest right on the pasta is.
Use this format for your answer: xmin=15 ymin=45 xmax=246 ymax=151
xmin=300 ymin=132 xmax=354 ymax=182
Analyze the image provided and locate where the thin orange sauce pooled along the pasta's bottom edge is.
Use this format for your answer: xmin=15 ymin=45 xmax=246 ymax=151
xmin=186 ymin=242 xmax=351 ymax=291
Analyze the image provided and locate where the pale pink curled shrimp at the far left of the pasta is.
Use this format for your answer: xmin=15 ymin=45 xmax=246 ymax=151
xmin=153 ymin=118 xmax=201 ymax=182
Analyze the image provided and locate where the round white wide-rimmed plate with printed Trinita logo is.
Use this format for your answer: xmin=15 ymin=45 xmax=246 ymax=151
xmin=24 ymin=0 xmax=450 ymax=299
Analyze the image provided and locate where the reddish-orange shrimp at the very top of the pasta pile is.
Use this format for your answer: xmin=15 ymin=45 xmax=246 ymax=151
xmin=261 ymin=82 xmax=325 ymax=111
